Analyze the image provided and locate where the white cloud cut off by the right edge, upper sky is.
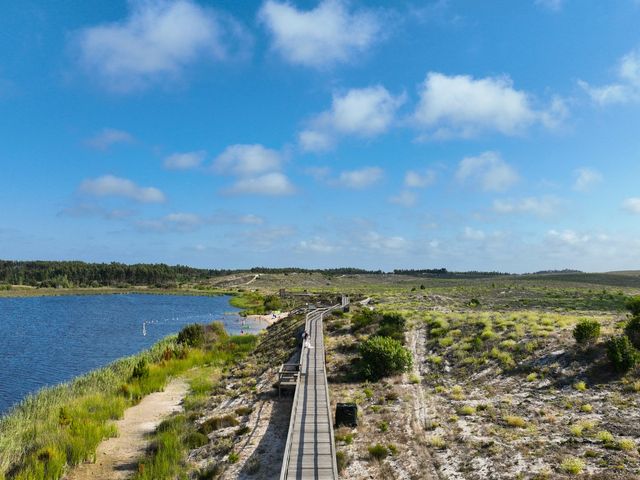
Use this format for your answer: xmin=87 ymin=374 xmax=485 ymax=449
xmin=578 ymin=49 xmax=640 ymax=105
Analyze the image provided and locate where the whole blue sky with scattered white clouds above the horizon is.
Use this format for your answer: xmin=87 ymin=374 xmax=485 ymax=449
xmin=0 ymin=0 xmax=640 ymax=272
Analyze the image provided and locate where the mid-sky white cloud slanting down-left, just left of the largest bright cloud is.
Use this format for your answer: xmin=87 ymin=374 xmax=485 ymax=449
xmin=298 ymin=85 xmax=405 ymax=152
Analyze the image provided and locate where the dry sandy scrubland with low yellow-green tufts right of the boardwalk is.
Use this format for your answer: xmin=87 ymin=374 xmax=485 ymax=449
xmin=327 ymin=282 xmax=640 ymax=479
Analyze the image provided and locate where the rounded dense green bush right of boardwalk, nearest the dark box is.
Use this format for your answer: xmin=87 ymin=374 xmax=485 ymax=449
xmin=360 ymin=336 xmax=413 ymax=380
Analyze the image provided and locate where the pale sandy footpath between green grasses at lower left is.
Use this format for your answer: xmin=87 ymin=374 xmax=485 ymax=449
xmin=65 ymin=378 xmax=189 ymax=480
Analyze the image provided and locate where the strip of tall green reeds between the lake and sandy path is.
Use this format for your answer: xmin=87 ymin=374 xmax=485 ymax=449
xmin=0 ymin=323 xmax=255 ymax=480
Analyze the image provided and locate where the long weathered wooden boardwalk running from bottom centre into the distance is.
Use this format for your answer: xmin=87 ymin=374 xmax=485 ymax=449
xmin=280 ymin=308 xmax=338 ymax=480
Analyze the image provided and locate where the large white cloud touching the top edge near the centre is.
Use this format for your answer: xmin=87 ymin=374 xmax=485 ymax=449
xmin=258 ymin=0 xmax=381 ymax=68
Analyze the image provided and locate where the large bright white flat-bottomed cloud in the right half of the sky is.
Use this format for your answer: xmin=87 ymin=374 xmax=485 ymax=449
xmin=414 ymin=72 xmax=566 ymax=138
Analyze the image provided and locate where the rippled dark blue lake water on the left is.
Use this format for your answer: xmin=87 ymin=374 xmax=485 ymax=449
xmin=0 ymin=295 xmax=264 ymax=414
